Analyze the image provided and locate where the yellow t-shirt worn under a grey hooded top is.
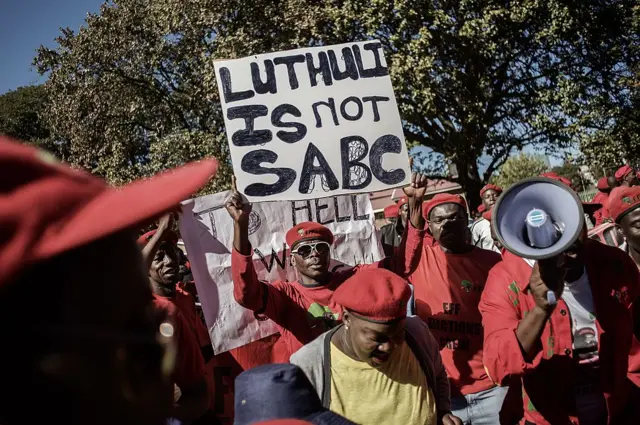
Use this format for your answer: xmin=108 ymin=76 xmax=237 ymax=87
xmin=329 ymin=342 xmax=437 ymax=425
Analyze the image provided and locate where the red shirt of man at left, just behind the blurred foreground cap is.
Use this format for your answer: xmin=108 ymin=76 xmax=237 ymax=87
xmin=153 ymin=295 xmax=205 ymax=389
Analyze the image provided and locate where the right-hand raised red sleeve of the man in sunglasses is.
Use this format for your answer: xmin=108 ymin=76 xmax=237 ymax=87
xmin=353 ymin=221 xmax=426 ymax=277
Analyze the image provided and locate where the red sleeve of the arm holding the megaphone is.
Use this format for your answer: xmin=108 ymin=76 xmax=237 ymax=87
xmin=478 ymin=263 xmax=543 ymax=385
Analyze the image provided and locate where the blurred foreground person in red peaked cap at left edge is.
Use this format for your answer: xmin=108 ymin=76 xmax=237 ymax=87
xmin=0 ymin=137 xmax=217 ymax=425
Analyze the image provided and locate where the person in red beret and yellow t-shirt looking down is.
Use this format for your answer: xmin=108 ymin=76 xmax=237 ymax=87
xmin=291 ymin=269 xmax=462 ymax=425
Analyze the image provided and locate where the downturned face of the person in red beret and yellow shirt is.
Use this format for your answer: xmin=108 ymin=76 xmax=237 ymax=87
xmin=342 ymin=311 xmax=406 ymax=367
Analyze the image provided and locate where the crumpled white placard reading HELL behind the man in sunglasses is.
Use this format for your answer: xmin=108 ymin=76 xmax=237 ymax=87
xmin=180 ymin=192 xmax=383 ymax=354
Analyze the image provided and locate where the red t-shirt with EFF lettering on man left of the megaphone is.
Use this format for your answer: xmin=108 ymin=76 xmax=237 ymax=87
xmin=409 ymin=235 xmax=500 ymax=395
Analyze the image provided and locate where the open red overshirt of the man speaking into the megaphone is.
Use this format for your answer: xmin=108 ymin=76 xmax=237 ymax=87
xmin=480 ymin=241 xmax=640 ymax=425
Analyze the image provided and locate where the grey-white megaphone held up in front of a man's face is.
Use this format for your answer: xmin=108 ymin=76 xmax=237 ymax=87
xmin=491 ymin=177 xmax=584 ymax=304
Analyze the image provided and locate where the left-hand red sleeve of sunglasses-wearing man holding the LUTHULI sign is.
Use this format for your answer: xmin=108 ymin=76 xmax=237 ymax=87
xmin=231 ymin=249 xmax=284 ymax=322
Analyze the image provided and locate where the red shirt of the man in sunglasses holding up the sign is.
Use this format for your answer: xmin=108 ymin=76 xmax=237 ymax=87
xmin=231 ymin=225 xmax=424 ymax=358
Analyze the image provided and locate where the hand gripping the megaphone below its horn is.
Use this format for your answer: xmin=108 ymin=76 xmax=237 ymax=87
xmin=529 ymin=256 xmax=566 ymax=312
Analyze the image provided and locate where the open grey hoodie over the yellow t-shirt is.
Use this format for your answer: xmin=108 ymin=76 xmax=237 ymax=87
xmin=290 ymin=317 xmax=451 ymax=418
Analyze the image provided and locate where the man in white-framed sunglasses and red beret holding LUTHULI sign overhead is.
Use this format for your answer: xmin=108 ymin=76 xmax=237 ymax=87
xmin=226 ymin=173 xmax=427 ymax=358
